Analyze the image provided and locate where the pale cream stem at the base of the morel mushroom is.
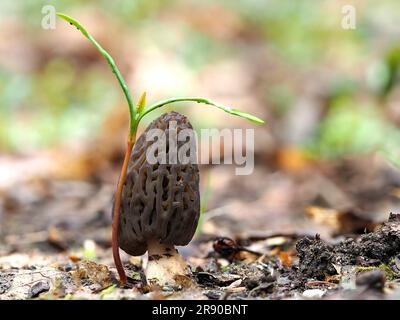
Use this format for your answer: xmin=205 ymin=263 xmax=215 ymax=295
xmin=145 ymin=241 xmax=189 ymax=285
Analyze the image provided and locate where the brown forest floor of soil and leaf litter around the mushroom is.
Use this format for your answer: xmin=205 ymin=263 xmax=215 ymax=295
xmin=0 ymin=153 xmax=400 ymax=300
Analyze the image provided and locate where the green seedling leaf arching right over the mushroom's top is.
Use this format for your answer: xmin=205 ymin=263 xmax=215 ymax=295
xmin=139 ymin=97 xmax=265 ymax=124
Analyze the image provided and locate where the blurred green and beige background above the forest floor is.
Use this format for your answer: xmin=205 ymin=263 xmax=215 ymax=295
xmin=0 ymin=0 xmax=400 ymax=161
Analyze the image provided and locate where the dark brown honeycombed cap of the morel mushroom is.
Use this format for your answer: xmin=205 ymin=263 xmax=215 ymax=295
xmin=118 ymin=112 xmax=200 ymax=256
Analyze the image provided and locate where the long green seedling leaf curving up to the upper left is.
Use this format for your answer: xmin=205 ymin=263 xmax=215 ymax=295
xmin=56 ymin=12 xmax=135 ymax=138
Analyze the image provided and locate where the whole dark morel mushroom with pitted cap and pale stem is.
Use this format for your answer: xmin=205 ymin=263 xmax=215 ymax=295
xmin=118 ymin=112 xmax=200 ymax=283
